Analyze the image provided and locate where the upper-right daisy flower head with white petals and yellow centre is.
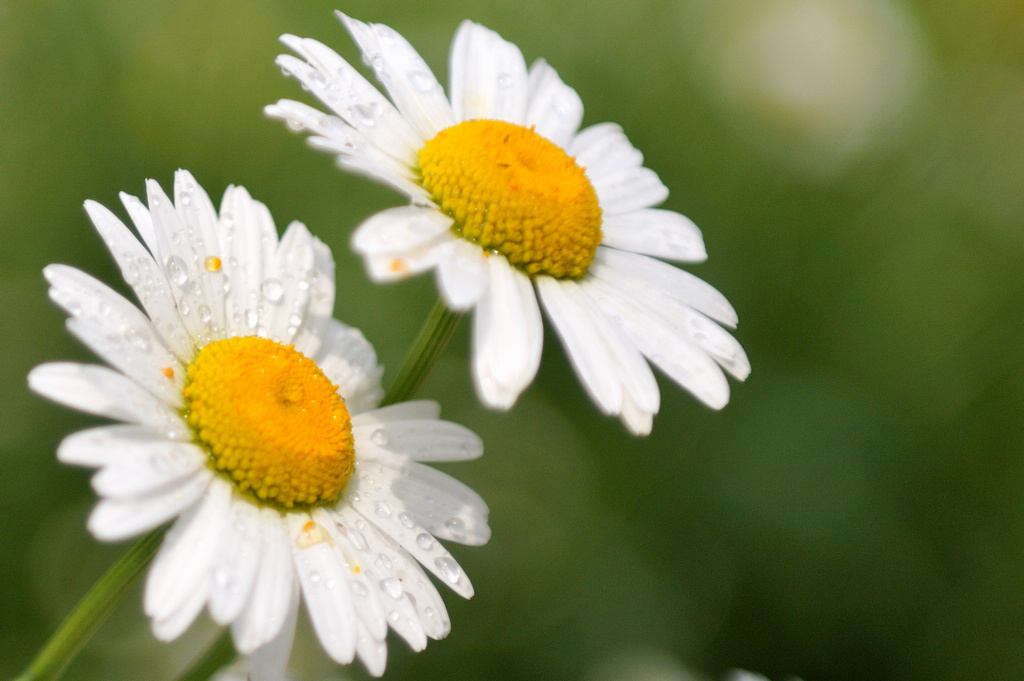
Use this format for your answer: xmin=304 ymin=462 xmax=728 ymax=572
xmin=266 ymin=12 xmax=750 ymax=434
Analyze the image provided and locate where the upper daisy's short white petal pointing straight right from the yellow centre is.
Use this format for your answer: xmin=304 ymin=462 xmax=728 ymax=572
xmin=601 ymin=208 xmax=708 ymax=262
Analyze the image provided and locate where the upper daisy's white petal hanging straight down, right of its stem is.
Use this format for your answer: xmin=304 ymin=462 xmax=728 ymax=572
xmin=473 ymin=257 xmax=544 ymax=410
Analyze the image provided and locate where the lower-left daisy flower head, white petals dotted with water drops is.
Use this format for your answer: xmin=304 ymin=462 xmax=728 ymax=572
xmin=29 ymin=171 xmax=490 ymax=681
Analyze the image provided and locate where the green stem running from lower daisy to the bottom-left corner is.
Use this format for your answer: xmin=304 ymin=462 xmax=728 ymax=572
xmin=14 ymin=527 xmax=166 ymax=681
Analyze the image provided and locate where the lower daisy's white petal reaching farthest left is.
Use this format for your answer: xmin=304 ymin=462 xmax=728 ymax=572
xmin=29 ymin=363 xmax=191 ymax=439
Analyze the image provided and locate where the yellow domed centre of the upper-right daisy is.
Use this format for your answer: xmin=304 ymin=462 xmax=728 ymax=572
xmin=420 ymin=121 xmax=601 ymax=279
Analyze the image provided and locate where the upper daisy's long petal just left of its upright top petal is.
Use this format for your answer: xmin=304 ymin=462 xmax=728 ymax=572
xmin=336 ymin=12 xmax=457 ymax=140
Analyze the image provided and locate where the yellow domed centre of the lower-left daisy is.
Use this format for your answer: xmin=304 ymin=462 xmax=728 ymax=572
xmin=184 ymin=336 xmax=354 ymax=508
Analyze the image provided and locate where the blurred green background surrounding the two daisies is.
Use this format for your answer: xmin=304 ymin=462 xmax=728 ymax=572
xmin=0 ymin=0 xmax=1024 ymax=681
